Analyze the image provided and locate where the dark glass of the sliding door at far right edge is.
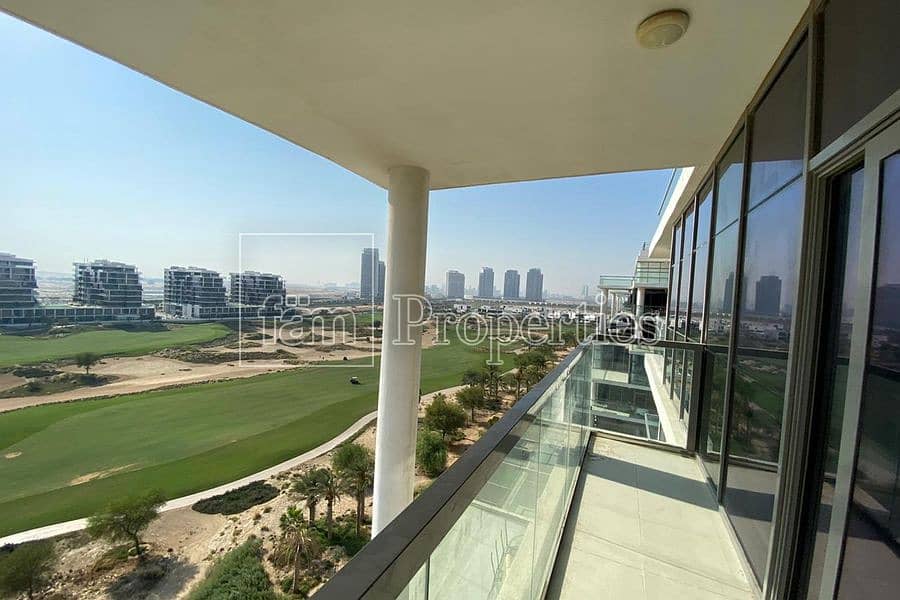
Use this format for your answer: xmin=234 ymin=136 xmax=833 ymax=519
xmin=838 ymin=154 xmax=900 ymax=600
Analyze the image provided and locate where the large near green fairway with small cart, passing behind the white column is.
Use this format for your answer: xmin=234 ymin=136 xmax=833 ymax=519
xmin=0 ymin=343 xmax=506 ymax=536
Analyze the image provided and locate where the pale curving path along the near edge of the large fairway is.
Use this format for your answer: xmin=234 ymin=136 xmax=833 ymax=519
xmin=0 ymin=411 xmax=378 ymax=547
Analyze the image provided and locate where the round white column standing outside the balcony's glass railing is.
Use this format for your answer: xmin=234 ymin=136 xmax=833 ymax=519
xmin=372 ymin=166 xmax=429 ymax=535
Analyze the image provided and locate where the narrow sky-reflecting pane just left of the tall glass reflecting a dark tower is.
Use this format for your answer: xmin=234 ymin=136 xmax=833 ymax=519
xmin=706 ymin=223 xmax=738 ymax=346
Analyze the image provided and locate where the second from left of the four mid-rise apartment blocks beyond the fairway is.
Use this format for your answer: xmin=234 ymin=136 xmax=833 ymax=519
xmin=72 ymin=260 xmax=143 ymax=308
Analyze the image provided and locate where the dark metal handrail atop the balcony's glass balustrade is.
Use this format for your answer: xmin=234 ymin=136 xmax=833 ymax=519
xmin=316 ymin=343 xmax=590 ymax=600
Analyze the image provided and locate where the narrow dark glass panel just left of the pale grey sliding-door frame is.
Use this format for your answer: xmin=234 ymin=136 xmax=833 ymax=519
xmin=807 ymin=167 xmax=863 ymax=598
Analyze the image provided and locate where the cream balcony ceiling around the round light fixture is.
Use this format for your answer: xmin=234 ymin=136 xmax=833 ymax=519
xmin=0 ymin=0 xmax=807 ymax=189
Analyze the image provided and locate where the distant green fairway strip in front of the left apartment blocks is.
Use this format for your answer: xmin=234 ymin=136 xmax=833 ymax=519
xmin=0 ymin=323 xmax=231 ymax=368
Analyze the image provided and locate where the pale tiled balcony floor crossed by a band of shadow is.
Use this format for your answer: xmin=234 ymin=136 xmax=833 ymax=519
xmin=547 ymin=437 xmax=755 ymax=600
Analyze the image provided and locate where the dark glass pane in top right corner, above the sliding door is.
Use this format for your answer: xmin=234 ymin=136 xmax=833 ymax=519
xmin=822 ymin=0 xmax=900 ymax=146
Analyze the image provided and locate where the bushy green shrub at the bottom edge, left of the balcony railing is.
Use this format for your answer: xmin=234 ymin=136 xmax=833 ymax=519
xmin=188 ymin=538 xmax=277 ymax=600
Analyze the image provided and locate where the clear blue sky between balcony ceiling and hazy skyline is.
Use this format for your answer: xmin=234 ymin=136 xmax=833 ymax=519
xmin=0 ymin=14 xmax=671 ymax=293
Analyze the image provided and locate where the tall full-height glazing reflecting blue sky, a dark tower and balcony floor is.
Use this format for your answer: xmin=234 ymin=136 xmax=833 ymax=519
xmin=717 ymin=42 xmax=807 ymax=581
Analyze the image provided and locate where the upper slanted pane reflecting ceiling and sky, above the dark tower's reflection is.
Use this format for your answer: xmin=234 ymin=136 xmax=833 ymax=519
xmin=748 ymin=42 xmax=806 ymax=208
